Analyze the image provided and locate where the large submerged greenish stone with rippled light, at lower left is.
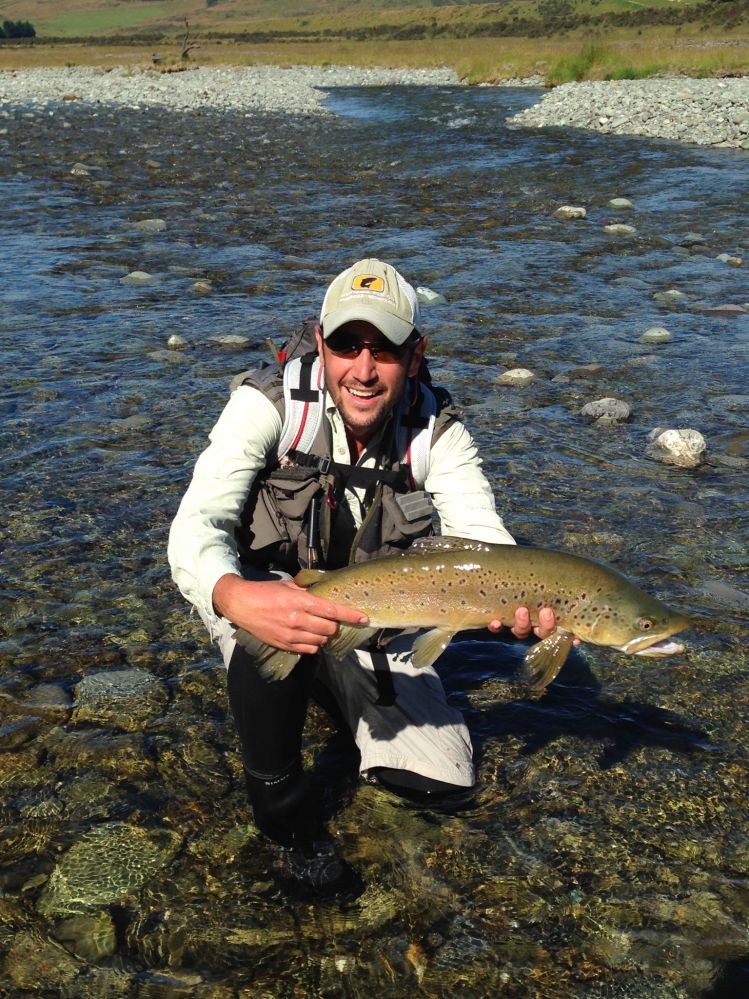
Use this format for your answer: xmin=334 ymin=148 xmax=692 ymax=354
xmin=37 ymin=822 xmax=181 ymax=917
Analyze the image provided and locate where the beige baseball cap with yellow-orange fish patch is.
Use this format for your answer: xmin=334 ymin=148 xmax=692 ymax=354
xmin=320 ymin=258 xmax=421 ymax=345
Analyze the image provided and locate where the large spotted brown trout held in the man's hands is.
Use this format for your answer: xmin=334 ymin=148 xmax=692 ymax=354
xmin=234 ymin=537 xmax=689 ymax=696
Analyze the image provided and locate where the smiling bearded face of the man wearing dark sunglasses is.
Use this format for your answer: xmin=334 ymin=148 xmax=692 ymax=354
xmin=317 ymin=320 xmax=425 ymax=443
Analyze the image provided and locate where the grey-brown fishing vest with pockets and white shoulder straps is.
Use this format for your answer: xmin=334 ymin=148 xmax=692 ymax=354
xmin=237 ymin=352 xmax=455 ymax=575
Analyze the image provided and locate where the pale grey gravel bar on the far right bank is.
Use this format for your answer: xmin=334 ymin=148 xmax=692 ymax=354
xmin=509 ymin=77 xmax=749 ymax=150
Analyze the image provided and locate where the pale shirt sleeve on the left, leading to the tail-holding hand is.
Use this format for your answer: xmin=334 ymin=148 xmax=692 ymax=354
xmin=168 ymin=385 xmax=283 ymax=634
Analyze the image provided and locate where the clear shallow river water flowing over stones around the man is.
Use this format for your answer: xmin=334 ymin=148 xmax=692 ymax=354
xmin=0 ymin=88 xmax=749 ymax=997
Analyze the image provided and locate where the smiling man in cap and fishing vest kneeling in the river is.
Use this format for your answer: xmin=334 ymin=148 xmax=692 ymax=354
xmin=169 ymin=259 xmax=554 ymax=886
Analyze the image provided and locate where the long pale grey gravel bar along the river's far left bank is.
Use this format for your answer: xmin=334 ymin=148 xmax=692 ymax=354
xmin=0 ymin=66 xmax=459 ymax=114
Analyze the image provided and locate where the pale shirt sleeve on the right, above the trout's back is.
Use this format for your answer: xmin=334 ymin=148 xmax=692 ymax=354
xmin=424 ymin=420 xmax=515 ymax=545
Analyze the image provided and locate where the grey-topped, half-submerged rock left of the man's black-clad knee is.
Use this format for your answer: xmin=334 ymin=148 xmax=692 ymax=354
xmin=73 ymin=669 xmax=169 ymax=732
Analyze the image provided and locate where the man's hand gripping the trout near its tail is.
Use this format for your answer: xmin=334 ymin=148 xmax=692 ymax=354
xmin=213 ymin=573 xmax=369 ymax=655
